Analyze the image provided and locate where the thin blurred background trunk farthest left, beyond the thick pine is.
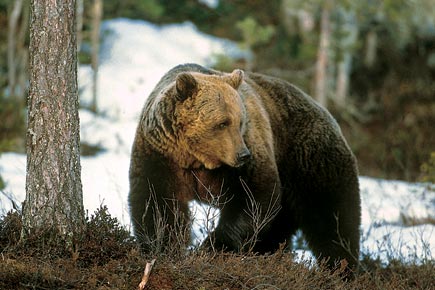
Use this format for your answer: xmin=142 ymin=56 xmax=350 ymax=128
xmin=8 ymin=0 xmax=23 ymax=96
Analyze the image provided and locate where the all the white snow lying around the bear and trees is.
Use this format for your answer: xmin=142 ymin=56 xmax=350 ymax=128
xmin=0 ymin=19 xmax=435 ymax=263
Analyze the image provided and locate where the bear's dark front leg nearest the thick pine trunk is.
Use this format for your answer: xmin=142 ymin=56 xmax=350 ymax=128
xmin=129 ymin=142 xmax=190 ymax=253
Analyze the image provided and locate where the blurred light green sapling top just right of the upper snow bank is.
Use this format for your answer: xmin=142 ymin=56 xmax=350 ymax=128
xmin=236 ymin=16 xmax=275 ymax=48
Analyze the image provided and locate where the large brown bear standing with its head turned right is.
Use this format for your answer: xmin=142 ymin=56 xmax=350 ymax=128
xmin=129 ymin=64 xmax=361 ymax=267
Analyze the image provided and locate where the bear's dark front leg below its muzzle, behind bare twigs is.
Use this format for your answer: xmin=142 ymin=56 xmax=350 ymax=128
xmin=201 ymin=171 xmax=281 ymax=252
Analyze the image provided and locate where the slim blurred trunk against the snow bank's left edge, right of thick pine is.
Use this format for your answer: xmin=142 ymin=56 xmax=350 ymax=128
xmin=91 ymin=0 xmax=103 ymax=113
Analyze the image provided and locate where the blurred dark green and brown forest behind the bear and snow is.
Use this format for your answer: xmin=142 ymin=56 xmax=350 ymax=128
xmin=0 ymin=0 xmax=435 ymax=182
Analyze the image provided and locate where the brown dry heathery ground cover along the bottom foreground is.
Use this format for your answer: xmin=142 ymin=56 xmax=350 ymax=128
xmin=0 ymin=208 xmax=435 ymax=290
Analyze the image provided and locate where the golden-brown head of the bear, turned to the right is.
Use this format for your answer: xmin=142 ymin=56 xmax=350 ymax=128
xmin=174 ymin=70 xmax=250 ymax=169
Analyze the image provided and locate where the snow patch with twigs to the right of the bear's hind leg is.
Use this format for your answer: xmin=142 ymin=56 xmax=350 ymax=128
xmin=360 ymin=177 xmax=435 ymax=262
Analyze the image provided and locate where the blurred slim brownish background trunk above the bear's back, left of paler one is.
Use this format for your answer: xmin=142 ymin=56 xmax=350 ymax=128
xmin=314 ymin=0 xmax=332 ymax=107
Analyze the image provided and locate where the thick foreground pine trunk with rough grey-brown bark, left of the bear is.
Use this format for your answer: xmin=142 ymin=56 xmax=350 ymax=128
xmin=22 ymin=0 xmax=84 ymax=241
